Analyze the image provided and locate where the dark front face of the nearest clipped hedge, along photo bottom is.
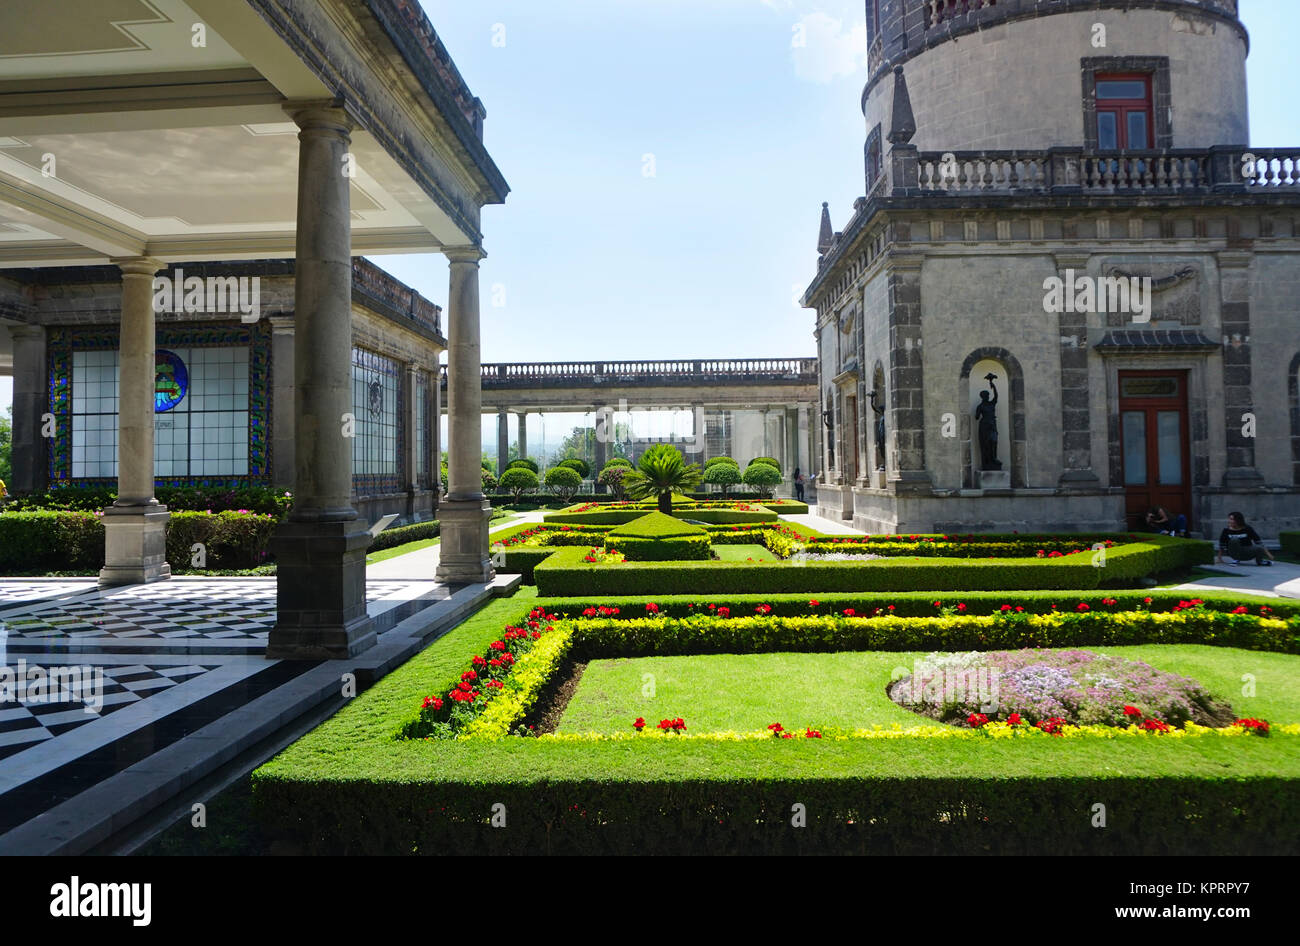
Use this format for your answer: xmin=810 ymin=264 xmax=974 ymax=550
xmin=254 ymin=769 xmax=1300 ymax=856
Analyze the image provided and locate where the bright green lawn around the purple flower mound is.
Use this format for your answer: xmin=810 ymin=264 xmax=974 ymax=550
xmin=559 ymin=645 xmax=1300 ymax=733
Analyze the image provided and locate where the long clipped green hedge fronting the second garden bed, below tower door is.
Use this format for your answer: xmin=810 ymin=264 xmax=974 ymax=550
xmin=533 ymin=535 xmax=1213 ymax=598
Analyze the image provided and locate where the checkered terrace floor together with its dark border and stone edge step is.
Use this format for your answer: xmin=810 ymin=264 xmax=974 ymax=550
xmin=0 ymin=569 xmax=519 ymax=854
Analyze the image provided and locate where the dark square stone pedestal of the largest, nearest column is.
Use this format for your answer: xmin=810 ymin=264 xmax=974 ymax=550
xmin=267 ymin=518 xmax=377 ymax=660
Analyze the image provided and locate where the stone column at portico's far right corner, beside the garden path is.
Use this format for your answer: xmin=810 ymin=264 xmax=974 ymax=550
xmin=437 ymin=247 xmax=495 ymax=583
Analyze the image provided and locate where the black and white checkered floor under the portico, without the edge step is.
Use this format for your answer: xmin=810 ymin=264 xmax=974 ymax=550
xmin=0 ymin=577 xmax=451 ymax=834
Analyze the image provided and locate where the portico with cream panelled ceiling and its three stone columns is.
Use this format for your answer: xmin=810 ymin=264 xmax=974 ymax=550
xmin=0 ymin=0 xmax=508 ymax=658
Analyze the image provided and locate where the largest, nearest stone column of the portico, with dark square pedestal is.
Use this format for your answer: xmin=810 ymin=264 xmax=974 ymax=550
xmin=267 ymin=105 xmax=376 ymax=660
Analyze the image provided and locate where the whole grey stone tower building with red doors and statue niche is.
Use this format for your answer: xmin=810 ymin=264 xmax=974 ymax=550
xmin=803 ymin=0 xmax=1300 ymax=538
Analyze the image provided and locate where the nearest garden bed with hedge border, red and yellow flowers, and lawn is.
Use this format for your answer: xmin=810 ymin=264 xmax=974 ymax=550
xmin=254 ymin=590 xmax=1300 ymax=854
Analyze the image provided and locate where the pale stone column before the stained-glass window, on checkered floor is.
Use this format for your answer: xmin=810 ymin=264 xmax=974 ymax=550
xmin=99 ymin=257 xmax=172 ymax=586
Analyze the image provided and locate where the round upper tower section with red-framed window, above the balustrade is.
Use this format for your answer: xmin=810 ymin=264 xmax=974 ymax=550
xmin=862 ymin=0 xmax=1249 ymax=153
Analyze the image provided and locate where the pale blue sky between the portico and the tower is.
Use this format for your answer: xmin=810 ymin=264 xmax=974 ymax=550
xmin=0 ymin=0 xmax=1300 ymax=433
